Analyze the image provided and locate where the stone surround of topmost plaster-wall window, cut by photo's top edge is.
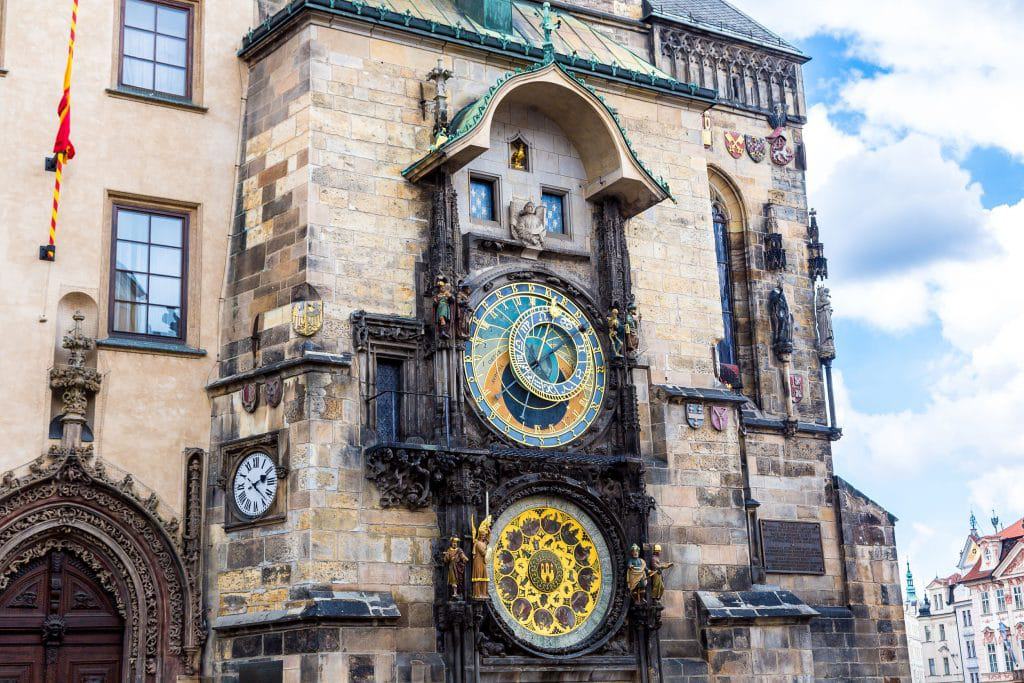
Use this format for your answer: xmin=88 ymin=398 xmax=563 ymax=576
xmin=106 ymin=0 xmax=207 ymax=113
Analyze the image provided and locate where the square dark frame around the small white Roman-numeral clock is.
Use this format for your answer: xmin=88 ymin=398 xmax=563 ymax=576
xmin=217 ymin=429 xmax=290 ymax=531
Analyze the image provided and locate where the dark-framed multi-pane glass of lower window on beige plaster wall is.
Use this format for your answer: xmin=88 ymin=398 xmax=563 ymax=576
xmin=110 ymin=206 xmax=187 ymax=340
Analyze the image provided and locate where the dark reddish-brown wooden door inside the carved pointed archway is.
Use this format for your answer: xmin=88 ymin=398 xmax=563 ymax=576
xmin=0 ymin=551 xmax=124 ymax=683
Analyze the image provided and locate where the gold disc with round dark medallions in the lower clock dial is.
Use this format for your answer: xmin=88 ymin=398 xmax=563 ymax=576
xmin=492 ymin=507 xmax=601 ymax=636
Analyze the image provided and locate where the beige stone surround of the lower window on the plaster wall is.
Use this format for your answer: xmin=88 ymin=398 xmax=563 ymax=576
xmin=97 ymin=189 xmax=203 ymax=353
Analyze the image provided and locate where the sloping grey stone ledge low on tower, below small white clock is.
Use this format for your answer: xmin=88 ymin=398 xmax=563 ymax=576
xmin=213 ymin=591 xmax=401 ymax=634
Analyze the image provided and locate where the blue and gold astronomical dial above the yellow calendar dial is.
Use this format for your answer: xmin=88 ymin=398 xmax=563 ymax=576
xmin=463 ymin=283 xmax=607 ymax=449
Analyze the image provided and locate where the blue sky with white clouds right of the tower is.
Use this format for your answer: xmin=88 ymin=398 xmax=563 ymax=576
xmin=734 ymin=0 xmax=1024 ymax=586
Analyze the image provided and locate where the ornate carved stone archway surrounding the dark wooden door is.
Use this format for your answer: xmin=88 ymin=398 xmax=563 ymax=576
xmin=0 ymin=447 xmax=206 ymax=681
